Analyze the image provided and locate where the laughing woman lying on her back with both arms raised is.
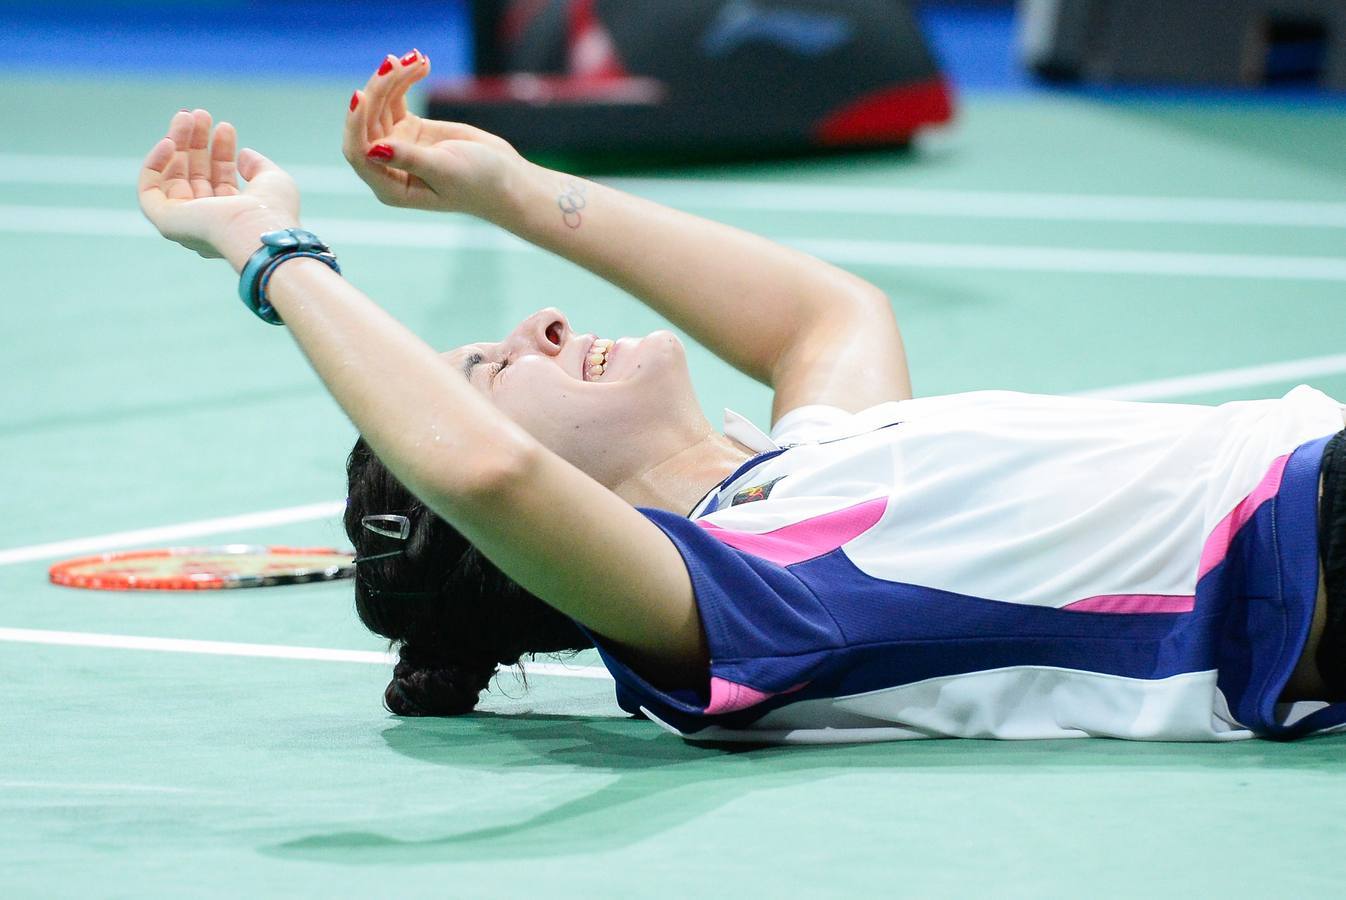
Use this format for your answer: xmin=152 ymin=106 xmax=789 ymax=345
xmin=140 ymin=52 xmax=1346 ymax=741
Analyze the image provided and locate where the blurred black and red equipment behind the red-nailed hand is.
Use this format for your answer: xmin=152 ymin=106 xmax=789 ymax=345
xmin=429 ymin=0 xmax=953 ymax=156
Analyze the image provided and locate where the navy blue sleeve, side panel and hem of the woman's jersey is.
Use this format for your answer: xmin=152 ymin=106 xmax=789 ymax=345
xmin=584 ymin=419 xmax=1346 ymax=737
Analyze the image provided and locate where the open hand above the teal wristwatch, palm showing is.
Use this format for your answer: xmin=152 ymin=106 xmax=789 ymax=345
xmin=140 ymin=109 xmax=299 ymax=269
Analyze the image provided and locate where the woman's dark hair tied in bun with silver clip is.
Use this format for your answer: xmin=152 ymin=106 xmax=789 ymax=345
xmin=346 ymin=437 xmax=594 ymax=716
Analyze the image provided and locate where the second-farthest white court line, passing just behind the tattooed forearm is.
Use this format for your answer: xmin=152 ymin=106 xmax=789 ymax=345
xmin=0 ymin=204 xmax=1346 ymax=283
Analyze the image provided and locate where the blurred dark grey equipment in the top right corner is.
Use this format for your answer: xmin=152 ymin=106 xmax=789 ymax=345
xmin=1019 ymin=0 xmax=1346 ymax=90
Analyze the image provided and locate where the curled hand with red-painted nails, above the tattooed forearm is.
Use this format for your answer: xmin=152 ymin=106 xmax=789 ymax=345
xmin=342 ymin=50 xmax=524 ymax=219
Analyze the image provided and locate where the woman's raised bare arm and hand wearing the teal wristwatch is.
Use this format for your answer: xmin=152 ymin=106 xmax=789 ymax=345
xmin=140 ymin=109 xmax=705 ymax=674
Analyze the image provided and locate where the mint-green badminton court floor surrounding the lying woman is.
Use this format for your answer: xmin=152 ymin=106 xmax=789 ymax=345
xmin=0 ymin=77 xmax=1346 ymax=897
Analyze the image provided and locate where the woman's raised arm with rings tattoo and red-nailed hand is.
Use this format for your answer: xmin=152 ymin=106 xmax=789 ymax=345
xmin=345 ymin=54 xmax=911 ymax=421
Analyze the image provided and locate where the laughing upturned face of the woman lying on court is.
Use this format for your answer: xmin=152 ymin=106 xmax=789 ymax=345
xmin=444 ymin=308 xmax=711 ymax=487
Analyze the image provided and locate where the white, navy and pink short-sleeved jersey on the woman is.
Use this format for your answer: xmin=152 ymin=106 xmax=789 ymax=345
xmin=586 ymin=387 xmax=1346 ymax=741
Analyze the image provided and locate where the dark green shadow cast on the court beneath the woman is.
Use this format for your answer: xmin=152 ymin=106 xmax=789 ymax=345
xmin=261 ymin=713 xmax=1346 ymax=865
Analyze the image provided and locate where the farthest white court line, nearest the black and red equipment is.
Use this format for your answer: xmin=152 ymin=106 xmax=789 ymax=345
xmin=0 ymin=153 xmax=1346 ymax=229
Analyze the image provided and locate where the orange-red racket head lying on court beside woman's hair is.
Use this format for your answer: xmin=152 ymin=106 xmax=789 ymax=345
xmin=47 ymin=543 xmax=355 ymax=591
